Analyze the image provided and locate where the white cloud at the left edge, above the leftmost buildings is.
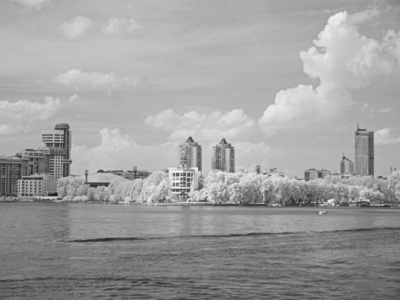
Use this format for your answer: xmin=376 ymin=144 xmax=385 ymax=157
xmin=0 ymin=96 xmax=60 ymax=135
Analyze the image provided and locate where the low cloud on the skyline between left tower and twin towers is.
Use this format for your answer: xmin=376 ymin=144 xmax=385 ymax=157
xmin=72 ymin=128 xmax=177 ymax=174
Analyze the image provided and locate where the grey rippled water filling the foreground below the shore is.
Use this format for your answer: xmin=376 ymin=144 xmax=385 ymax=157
xmin=0 ymin=203 xmax=400 ymax=299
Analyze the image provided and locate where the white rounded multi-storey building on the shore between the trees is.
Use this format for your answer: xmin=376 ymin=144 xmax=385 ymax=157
xmin=168 ymin=167 xmax=199 ymax=201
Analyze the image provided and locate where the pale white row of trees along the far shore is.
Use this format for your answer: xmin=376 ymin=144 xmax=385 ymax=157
xmin=57 ymin=171 xmax=400 ymax=205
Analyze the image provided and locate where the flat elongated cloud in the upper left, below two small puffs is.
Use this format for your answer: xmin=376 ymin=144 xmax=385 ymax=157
xmin=54 ymin=69 xmax=143 ymax=91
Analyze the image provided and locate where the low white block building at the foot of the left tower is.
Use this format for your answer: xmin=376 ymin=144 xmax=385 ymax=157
xmin=18 ymin=174 xmax=57 ymax=197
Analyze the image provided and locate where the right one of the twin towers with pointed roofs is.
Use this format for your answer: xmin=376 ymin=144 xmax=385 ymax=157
xmin=211 ymin=139 xmax=235 ymax=173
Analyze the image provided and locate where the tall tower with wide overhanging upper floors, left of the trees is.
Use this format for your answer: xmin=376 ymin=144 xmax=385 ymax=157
xmin=42 ymin=123 xmax=72 ymax=179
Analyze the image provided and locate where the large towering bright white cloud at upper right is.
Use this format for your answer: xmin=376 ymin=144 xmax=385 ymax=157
xmin=258 ymin=9 xmax=400 ymax=136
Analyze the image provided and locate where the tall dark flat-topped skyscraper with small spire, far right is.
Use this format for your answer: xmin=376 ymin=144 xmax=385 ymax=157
xmin=355 ymin=124 xmax=374 ymax=176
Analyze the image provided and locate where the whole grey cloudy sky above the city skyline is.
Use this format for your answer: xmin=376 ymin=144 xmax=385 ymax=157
xmin=0 ymin=0 xmax=400 ymax=178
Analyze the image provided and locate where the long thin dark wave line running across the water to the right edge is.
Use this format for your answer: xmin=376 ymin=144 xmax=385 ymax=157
xmin=67 ymin=227 xmax=400 ymax=243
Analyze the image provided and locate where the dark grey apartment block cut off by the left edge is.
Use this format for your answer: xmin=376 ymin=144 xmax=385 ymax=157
xmin=0 ymin=156 xmax=23 ymax=197
